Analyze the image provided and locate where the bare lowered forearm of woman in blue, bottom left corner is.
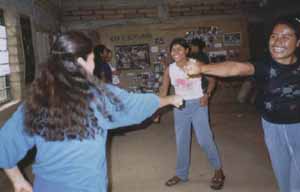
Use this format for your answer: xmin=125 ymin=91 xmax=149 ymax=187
xmin=4 ymin=167 xmax=33 ymax=192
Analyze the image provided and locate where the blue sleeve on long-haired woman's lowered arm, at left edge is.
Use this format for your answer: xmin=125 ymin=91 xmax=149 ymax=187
xmin=0 ymin=105 xmax=34 ymax=168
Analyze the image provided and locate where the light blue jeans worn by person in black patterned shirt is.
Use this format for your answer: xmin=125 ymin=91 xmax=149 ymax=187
xmin=262 ymin=119 xmax=300 ymax=192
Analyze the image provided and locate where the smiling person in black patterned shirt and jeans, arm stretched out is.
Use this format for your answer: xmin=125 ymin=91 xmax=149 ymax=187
xmin=185 ymin=18 xmax=300 ymax=192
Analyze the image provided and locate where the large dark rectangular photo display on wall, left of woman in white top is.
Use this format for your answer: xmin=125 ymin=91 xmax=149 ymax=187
xmin=115 ymin=44 xmax=150 ymax=69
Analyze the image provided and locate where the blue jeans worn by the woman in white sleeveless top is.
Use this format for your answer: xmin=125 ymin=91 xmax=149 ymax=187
xmin=174 ymin=99 xmax=221 ymax=181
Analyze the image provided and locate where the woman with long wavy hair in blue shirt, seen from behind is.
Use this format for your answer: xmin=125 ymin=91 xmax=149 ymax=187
xmin=0 ymin=32 xmax=182 ymax=192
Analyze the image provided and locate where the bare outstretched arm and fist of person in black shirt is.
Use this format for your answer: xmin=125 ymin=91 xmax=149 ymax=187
xmin=185 ymin=61 xmax=255 ymax=77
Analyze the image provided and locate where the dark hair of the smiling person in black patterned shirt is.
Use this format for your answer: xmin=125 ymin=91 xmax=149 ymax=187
xmin=272 ymin=16 xmax=300 ymax=40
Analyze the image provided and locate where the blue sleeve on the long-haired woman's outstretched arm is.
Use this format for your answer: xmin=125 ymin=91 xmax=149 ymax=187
xmin=94 ymin=86 xmax=159 ymax=129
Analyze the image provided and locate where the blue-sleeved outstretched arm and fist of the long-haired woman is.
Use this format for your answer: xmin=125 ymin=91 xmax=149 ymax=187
xmin=91 ymin=85 xmax=183 ymax=129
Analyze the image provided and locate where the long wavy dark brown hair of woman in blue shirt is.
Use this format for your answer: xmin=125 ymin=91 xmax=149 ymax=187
xmin=25 ymin=32 xmax=121 ymax=141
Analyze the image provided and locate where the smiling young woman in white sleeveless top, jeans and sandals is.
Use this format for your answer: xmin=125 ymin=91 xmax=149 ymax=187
xmin=160 ymin=38 xmax=225 ymax=189
